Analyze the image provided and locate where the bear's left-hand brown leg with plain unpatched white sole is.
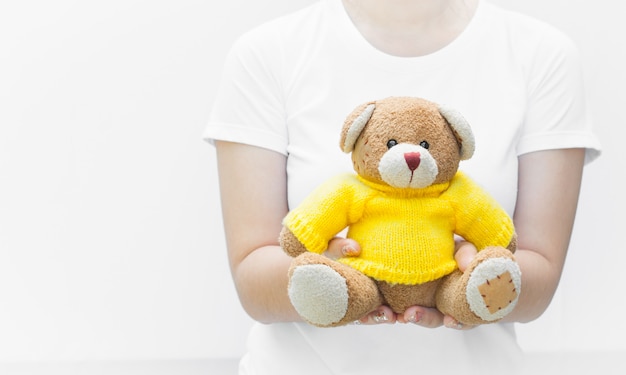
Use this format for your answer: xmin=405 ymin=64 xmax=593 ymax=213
xmin=287 ymin=253 xmax=381 ymax=327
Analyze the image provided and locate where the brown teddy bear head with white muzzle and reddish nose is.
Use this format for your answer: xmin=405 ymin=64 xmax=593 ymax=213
xmin=340 ymin=97 xmax=474 ymax=189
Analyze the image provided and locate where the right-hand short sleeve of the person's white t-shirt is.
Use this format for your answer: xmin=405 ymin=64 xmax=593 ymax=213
xmin=517 ymin=29 xmax=600 ymax=162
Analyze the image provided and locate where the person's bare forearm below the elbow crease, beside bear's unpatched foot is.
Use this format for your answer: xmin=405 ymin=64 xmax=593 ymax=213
xmin=233 ymin=245 xmax=301 ymax=323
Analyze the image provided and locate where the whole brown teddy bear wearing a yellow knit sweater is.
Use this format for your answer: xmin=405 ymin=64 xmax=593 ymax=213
xmin=279 ymin=97 xmax=521 ymax=327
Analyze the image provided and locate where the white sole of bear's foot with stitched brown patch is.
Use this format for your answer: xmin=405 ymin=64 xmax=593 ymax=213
xmin=466 ymin=258 xmax=522 ymax=322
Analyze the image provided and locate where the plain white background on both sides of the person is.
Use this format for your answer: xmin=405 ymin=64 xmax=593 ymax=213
xmin=0 ymin=0 xmax=626 ymax=362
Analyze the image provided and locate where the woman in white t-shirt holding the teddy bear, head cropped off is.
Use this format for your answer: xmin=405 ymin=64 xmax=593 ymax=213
xmin=205 ymin=0 xmax=599 ymax=374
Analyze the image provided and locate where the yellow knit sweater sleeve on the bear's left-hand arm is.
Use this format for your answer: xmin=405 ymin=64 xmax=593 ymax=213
xmin=283 ymin=175 xmax=363 ymax=254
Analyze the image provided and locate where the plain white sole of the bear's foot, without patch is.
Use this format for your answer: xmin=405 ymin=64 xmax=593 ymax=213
xmin=288 ymin=264 xmax=348 ymax=327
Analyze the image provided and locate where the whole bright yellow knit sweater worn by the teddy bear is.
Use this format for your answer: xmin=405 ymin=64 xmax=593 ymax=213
xmin=284 ymin=172 xmax=514 ymax=284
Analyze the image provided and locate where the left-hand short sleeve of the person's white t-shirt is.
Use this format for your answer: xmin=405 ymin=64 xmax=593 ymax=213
xmin=203 ymin=31 xmax=287 ymax=154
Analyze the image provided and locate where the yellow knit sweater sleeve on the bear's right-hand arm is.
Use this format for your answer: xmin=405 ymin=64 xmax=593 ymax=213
xmin=447 ymin=173 xmax=515 ymax=251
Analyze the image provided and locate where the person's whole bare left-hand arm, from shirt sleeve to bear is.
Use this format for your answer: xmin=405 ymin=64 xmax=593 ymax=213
xmin=216 ymin=142 xmax=298 ymax=323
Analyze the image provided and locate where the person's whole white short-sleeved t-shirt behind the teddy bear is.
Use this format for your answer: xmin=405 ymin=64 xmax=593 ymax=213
xmin=204 ymin=0 xmax=599 ymax=375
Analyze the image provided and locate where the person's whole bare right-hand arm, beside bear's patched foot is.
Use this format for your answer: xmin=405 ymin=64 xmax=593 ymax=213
xmin=506 ymin=149 xmax=585 ymax=322
